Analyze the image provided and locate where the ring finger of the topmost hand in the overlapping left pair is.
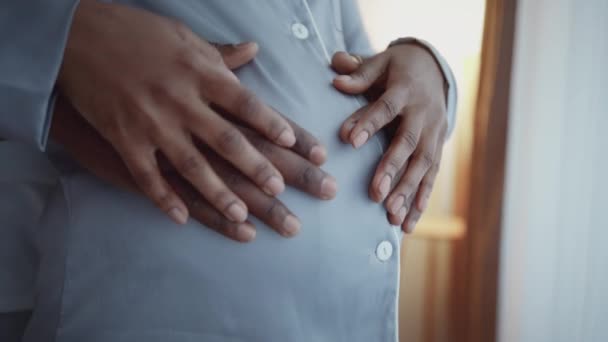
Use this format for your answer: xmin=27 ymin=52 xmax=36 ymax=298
xmin=159 ymin=134 xmax=247 ymax=222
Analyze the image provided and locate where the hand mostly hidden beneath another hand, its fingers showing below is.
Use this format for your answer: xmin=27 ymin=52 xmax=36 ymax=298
xmin=51 ymin=46 xmax=337 ymax=242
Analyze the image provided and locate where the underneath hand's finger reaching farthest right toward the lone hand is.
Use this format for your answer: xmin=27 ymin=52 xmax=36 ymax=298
xmin=244 ymin=129 xmax=338 ymax=200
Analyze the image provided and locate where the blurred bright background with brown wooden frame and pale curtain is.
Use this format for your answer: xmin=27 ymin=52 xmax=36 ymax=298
xmin=358 ymin=0 xmax=608 ymax=342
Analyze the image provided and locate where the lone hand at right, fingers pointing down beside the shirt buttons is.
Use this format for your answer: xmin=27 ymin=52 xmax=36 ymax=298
xmin=332 ymin=44 xmax=447 ymax=233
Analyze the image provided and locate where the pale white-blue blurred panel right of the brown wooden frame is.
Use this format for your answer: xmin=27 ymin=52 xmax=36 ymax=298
xmin=499 ymin=0 xmax=608 ymax=342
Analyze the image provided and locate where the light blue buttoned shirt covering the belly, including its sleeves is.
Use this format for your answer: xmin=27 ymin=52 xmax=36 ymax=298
xmin=0 ymin=0 xmax=456 ymax=342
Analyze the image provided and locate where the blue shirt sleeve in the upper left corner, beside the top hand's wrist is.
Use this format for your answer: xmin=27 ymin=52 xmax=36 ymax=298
xmin=0 ymin=0 xmax=78 ymax=149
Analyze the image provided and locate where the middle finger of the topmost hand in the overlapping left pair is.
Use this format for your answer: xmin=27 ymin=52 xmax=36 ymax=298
xmin=190 ymin=106 xmax=285 ymax=196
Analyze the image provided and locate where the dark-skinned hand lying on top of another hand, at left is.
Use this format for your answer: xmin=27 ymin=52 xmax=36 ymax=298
xmin=57 ymin=0 xmax=325 ymax=223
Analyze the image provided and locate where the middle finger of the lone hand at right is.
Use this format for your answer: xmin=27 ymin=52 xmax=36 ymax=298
xmin=369 ymin=114 xmax=423 ymax=202
